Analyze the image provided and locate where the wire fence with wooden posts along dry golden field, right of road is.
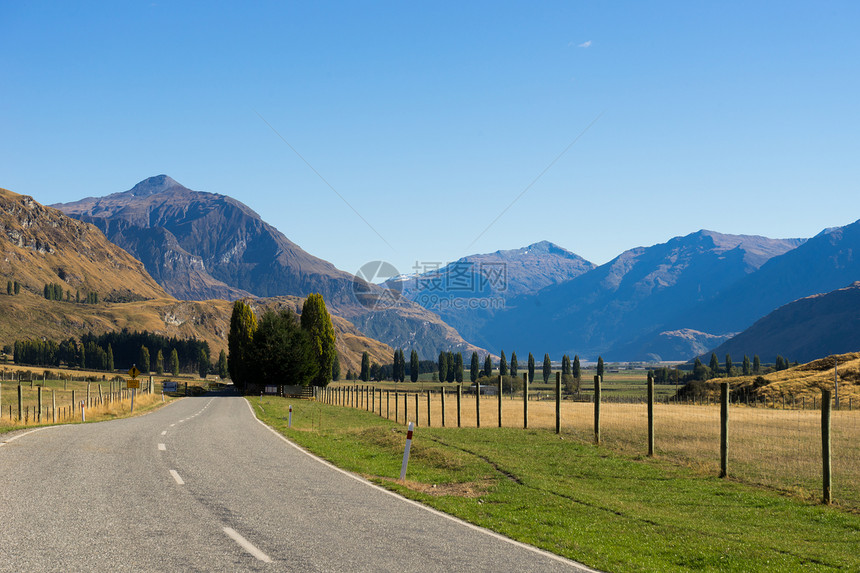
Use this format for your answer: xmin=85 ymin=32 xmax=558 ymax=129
xmin=317 ymin=380 xmax=860 ymax=511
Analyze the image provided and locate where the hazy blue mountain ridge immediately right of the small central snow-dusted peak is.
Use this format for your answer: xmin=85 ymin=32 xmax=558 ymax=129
xmin=484 ymin=230 xmax=804 ymax=360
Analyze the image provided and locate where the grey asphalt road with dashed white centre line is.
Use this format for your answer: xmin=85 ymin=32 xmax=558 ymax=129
xmin=0 ymin=396 xmax=586 ymax=572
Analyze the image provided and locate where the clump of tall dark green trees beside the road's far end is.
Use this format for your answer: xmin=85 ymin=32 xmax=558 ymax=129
xmin=227 ymin=294 xmax=340 ymax=391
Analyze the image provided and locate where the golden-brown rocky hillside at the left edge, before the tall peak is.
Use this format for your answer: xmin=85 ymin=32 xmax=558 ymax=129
xmin=0 ymin=189 xmax=170 ymax=301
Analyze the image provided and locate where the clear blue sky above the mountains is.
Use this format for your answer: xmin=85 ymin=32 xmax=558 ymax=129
xmin=0 ymin=0 xmax=860 ymax=278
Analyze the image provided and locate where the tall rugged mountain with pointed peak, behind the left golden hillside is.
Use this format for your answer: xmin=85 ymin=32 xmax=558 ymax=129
xmin=55 ymin=175 xmax=477 ymax=357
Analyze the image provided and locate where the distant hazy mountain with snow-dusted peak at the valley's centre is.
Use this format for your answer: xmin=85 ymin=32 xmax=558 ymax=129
xmin=385 ymin=241 xmax=595 ymax=346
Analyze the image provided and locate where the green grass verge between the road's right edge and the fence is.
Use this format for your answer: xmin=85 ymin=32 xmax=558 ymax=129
xmin=250 ymin=397 xmax=860 ymax=572
